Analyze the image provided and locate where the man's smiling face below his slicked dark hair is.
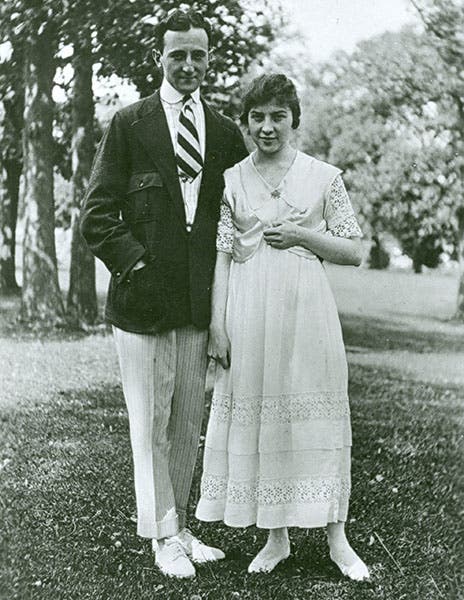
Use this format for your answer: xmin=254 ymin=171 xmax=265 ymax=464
xmin=160 ymin=28 xmax=208 ymax=94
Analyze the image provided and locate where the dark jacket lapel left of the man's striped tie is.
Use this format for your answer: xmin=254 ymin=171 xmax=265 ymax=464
xmin=132 ymin=91 xmax=185 ymax=224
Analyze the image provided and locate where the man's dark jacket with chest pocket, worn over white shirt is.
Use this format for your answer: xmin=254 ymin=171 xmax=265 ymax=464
xmin=81 ymin=92 xmax=247 ymax=333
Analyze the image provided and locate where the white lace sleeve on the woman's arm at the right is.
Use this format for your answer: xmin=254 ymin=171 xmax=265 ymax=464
xmin=324 ymin=175 xmax=363 ymax=237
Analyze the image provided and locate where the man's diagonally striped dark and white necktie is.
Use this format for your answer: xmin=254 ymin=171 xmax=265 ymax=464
xmin=176 ymin=95 xmax=203 ymax=180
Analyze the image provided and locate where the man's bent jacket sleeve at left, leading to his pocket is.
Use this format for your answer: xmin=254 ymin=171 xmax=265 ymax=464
xmin=81 ymin=113 xmax=145 ymax=279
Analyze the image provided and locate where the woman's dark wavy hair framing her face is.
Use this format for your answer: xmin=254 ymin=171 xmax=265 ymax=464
xmin=240 ymin=73 xmax=301 ymax=129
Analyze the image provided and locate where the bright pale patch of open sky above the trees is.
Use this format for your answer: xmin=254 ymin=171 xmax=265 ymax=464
xmin=282 ymin=0 xmax=418 ymax=61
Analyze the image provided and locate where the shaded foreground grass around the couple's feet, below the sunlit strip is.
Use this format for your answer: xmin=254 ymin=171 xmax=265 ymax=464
xmin=0 ymin=367 xmax=463 ymax=600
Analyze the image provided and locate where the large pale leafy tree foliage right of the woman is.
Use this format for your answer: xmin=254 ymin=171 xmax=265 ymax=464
xmin=300 ymin=21 xmax=463 ymax=269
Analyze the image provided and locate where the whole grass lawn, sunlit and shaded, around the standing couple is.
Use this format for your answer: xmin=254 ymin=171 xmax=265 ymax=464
xmin=0 ymin=268 xmax=464 ymax=600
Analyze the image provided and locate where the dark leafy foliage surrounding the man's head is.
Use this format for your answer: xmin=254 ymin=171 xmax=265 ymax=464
xmin=97 ymin=0 xmax=283 ymax=115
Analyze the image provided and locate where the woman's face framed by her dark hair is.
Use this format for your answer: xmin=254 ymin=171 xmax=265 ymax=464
xmin=248 ymin=100 xmax=293 ymax=154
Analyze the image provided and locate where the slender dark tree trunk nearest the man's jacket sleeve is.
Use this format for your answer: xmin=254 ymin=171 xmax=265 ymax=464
xmin=67 ymin=36 xmax=98 ymax=325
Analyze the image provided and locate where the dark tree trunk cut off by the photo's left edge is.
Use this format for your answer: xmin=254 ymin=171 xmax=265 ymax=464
xmin=0 ymin=160 xmax=22 ymax=295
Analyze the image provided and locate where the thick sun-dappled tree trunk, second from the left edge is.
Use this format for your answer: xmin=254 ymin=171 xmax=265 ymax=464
xmin=21 ymin=26 xmax=64 ymax=325
